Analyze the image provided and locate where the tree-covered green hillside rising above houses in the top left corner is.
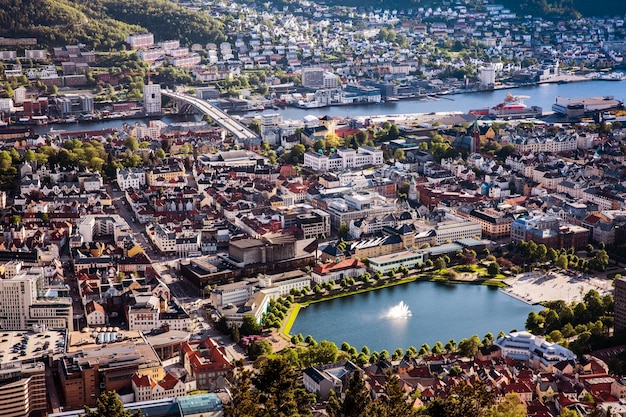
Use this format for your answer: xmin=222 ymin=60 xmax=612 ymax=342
xmin=0 ymin=0 xmax=226 ymax=50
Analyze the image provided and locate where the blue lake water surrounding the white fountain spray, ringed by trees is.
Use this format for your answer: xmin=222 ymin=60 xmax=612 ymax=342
xmin=291 ymin=282 xmax=541 ymax=353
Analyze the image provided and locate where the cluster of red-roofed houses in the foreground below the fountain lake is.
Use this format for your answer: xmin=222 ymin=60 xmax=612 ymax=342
xmin=303 ymin=332 xmax=626 ymax=416
